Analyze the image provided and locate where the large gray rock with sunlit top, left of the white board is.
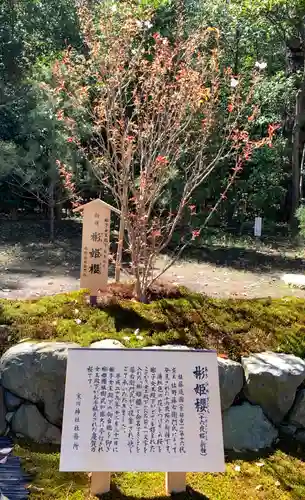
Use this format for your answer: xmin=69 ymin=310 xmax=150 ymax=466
xmin=0 ymin=342 xmax=79 ymax=426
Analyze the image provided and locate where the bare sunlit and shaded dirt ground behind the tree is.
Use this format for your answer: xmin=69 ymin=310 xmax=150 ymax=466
xmin=0 ymin=221 xmax=305 ymax=299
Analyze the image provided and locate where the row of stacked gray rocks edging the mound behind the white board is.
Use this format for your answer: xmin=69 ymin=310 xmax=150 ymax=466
xmin=0 ymin=339 xmax=305 ymax=450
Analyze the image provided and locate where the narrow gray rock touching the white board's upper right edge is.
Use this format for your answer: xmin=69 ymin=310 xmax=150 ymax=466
xmin=217 ymin=358 xmax=244 ymax=411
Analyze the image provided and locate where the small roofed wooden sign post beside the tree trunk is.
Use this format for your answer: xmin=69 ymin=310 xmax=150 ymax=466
xmin=74 ymin=199 xmax=120 ymax=305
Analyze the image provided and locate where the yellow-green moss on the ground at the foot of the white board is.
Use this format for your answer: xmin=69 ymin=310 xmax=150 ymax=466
xmin=15 ymin=446 xmax=305 ymax=500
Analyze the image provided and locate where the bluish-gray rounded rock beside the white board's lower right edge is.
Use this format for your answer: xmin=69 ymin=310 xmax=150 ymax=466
xmin=222 ymin=402 xmax=278 ymax=451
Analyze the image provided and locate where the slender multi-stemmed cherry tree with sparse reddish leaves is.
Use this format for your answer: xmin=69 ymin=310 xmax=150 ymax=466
xmin=49 ymin=2 xmax=276 ymax=301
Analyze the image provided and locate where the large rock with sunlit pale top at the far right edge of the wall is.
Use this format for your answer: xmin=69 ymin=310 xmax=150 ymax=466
xmin=242 ymin=352 xmax=305 ymax=424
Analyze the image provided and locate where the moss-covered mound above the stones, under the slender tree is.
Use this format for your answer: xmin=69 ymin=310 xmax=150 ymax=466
xmin=0 ymin=291 xmax=305 ymax=360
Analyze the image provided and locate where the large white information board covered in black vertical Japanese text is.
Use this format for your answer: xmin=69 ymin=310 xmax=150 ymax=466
xmin=60 ymin=348 xmax=225 ymax=472
